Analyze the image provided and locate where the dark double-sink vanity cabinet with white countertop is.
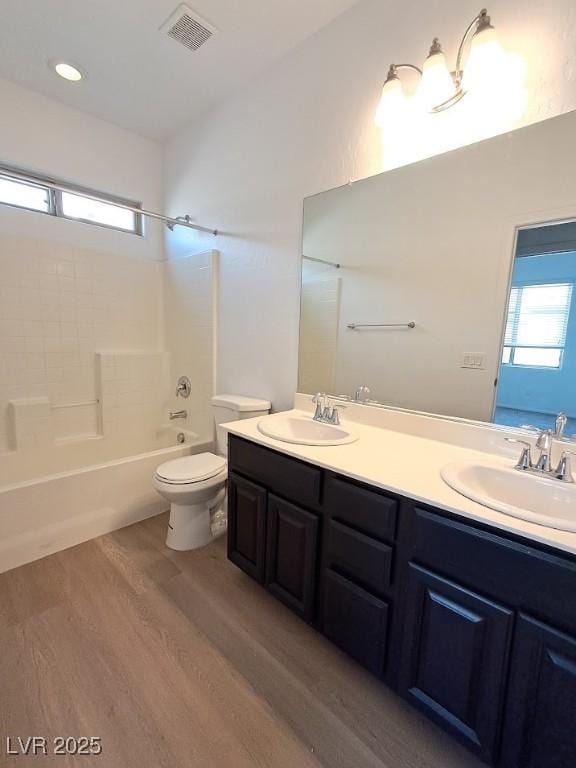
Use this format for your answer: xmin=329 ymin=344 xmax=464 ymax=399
xmin=227 ymin=395 xmax=576 ymax=768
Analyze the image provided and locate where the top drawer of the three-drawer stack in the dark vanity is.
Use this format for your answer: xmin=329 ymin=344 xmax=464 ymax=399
xmin=324 ymin=475 xmax=399 ymax=541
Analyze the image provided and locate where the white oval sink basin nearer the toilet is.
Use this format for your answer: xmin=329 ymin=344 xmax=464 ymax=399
xmin=258 ymin=413 xmax=358 ymax=445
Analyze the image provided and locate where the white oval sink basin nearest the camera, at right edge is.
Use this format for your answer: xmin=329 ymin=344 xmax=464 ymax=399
xmin=440 ymin=463 xmax=576 ymax=531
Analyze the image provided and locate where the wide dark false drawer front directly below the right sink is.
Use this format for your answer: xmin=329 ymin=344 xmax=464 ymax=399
xmin=411 ymin=506 xmax=576 ymax=632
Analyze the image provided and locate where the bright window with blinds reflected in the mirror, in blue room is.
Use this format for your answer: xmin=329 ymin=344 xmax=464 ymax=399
xmin=502 ymin=283 xmax=572 ymax=368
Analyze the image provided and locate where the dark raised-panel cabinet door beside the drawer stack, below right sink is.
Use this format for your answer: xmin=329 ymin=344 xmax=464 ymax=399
xmin=400 ymin=564 xmax=513 ymax=762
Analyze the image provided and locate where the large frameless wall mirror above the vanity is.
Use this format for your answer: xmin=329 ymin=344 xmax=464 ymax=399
xmin=299 ymin=113 xmax=576 ymax=434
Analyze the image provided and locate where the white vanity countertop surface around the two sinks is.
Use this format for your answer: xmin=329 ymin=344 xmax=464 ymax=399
xmin=222 ymin=410 xmax=576 ymax=554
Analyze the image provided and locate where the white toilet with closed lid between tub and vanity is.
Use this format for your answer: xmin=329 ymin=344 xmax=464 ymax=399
xmin=153 ymin=395 xmax=270 ymax=551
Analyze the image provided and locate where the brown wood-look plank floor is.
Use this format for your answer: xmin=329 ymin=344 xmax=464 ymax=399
xmin=0 ymin=515 xmax=480 ymax=768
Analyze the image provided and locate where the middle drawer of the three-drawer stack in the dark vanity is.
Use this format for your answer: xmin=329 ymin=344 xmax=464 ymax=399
xmin=326 ymin=520 xmax=393 ymax=592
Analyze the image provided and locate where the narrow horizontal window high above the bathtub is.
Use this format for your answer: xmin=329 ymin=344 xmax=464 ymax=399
xmin=0 ymin=167 xmax=142 ymax=235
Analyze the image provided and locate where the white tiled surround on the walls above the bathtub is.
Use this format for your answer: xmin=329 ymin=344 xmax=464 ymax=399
xmin=0 ymin=234 xmax=212 ymax=485
